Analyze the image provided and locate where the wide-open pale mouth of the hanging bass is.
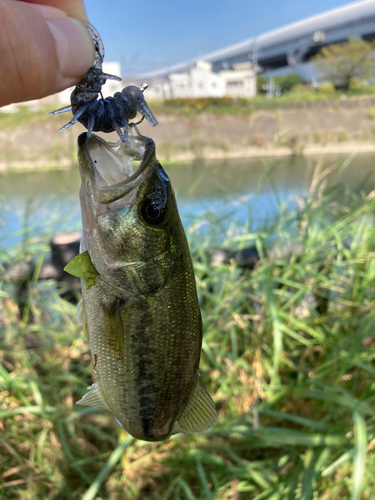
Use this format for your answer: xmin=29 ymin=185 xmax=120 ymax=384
xmin=78 ymin=129 xmax=155 ymax=209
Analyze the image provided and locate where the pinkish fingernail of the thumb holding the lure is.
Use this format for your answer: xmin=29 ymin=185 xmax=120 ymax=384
xmin=46 ymin=18 xmax=95 ymax=78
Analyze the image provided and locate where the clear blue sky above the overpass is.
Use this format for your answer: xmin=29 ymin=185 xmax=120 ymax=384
xmin=86 ymin=0 xmax=360 ymax=76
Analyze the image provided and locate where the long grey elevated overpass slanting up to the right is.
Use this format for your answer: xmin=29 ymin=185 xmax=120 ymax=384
xmin=141 ymin=0 xmax=375 ymax=81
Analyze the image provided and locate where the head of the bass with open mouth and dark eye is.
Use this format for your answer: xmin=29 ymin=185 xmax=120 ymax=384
xmin=78 ymin=127 xmax=171 ymax=275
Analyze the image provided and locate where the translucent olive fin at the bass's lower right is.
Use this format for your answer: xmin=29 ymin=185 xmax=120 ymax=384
xmin=173 ymin=378 xmax=216 ymax=434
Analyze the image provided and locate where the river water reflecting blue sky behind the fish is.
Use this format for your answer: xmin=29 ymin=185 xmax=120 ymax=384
xmin=0 ymin=154 xmax=375 ymax=246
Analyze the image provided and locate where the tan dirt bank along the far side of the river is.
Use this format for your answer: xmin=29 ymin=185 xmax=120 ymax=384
xmin=0 ymin=100 xmax=375 ymax=171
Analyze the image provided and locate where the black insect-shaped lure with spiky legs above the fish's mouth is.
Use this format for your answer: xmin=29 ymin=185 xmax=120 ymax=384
xmin=50 ymin=24 xmax=158 ymax=142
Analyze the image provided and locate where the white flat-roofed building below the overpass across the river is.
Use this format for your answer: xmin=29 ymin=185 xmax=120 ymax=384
xmin=147 ymin=61 xmax=256 ymax=101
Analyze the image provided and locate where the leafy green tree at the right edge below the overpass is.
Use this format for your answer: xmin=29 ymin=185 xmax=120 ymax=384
xmin=312 ymin=38 xmax=375 ymax=90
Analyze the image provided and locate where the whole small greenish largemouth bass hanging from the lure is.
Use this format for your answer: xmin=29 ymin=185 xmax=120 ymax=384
xmin=71 ymin=133 xmax=216 ymax=441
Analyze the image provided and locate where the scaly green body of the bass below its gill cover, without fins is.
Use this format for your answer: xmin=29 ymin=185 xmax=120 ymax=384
xmin=83 ymin=273 xmax=201 ymax=441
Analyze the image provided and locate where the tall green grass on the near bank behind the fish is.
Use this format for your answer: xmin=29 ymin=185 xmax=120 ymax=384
xmin=0 ymin=163 xmax=375 ymax=500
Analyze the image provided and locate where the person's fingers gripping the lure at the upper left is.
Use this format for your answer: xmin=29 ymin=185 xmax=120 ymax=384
xmin=0 ymin=0 xmax=95 ymax=106
